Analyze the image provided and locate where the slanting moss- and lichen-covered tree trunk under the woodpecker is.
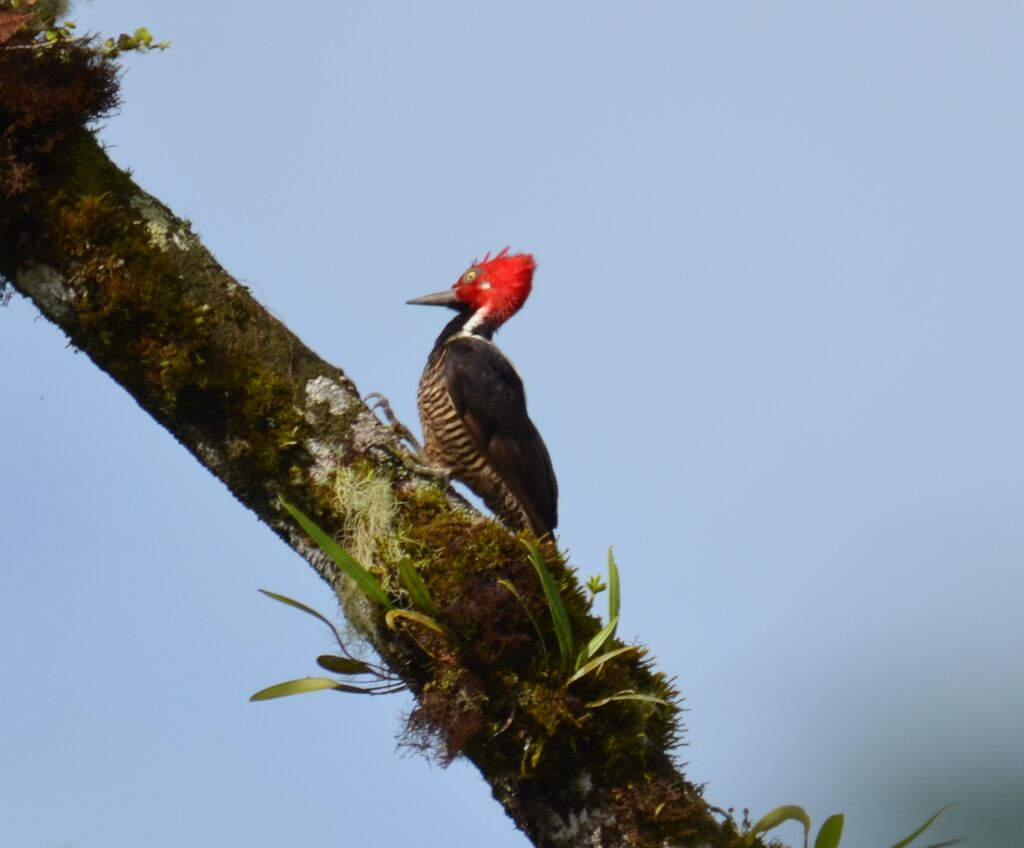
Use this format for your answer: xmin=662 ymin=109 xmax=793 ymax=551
xmin=0 ymin=45 xmax=743 ymax=848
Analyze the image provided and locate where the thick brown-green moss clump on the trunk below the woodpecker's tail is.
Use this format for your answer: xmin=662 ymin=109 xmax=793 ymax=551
xmin=387 ymin=490 xmax=679 ymax=807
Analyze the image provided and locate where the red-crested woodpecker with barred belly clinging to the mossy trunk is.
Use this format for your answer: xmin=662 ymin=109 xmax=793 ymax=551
xmin=408 ymin=248 xmax=558 ymax=536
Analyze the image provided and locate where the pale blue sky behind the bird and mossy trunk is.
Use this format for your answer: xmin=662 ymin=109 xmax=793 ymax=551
xmin=0 ymin=0 xmax=1024 ymax=848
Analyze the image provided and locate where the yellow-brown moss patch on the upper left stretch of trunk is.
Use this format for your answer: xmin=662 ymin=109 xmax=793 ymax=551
xmin=29 ymin=131 xmax=303 ymax=473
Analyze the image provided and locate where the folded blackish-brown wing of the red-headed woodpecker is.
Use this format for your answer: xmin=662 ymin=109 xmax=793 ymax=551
xmin=444 ymin=338 xmax=558 ymax=536
